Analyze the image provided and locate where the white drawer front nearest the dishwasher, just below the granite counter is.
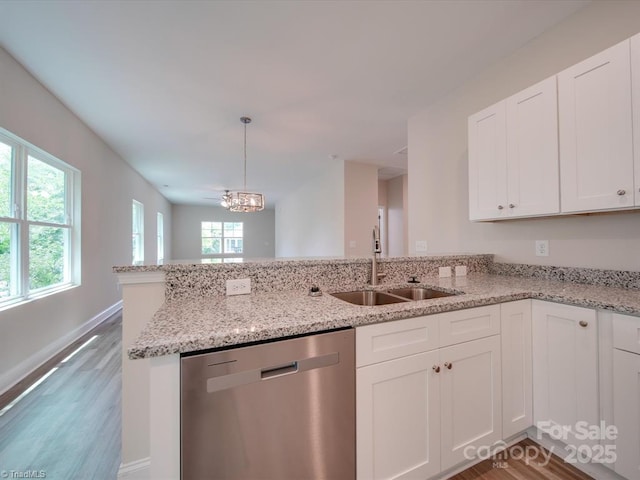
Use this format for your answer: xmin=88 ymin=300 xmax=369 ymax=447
xmin=356 ymin=316 xmax=438 ymax=367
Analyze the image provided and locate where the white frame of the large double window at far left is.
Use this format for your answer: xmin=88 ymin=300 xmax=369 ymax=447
xmin=0 ymin=128 xmax=81 ymax=309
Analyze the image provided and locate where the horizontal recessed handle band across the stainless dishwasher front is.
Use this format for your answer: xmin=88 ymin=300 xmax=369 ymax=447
xmin=207 ymin=352 xmax=340 ymax=393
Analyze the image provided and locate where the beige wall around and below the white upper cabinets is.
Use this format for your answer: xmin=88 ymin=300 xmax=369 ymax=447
xmin=409 ymin=0 xmax=640 ymax=270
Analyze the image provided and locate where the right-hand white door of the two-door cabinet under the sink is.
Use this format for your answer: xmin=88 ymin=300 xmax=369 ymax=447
xmin=440 ymin=335 xmax=502 ymax=470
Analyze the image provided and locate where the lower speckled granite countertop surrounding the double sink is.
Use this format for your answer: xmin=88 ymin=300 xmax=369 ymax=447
xmin=128 ymin=274 xmax=640 ymax=359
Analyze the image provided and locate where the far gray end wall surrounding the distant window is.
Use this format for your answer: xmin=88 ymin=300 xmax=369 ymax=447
xmin=171 ymin=205 xmax=275 ymax=260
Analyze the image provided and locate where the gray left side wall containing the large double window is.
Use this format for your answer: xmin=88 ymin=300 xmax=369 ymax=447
xmin=0 ymin=48 xmax=171 ymax=393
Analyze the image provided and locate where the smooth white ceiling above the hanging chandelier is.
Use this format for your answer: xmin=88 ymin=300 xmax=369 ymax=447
xmin=0 ymin=0 xmax=589 ymax=205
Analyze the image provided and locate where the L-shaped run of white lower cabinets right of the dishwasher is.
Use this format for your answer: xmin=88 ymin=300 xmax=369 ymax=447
xmin=356 ymin=300 xmax=640 ymax=480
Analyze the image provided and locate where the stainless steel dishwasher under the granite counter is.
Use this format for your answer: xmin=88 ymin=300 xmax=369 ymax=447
xmin=180 ymin=329 xmax=356 ymax=480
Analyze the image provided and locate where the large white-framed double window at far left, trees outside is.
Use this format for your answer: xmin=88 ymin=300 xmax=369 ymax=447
xmin=0 ymin=129 xmax=80 ymax=304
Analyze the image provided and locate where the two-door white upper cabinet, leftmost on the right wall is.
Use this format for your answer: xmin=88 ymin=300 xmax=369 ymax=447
xmin=469 ymin=76 xmax=560 ymax=220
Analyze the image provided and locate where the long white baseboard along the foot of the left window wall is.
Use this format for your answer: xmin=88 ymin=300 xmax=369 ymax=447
xmin=0 ymin=300 xmax=122 ymax=395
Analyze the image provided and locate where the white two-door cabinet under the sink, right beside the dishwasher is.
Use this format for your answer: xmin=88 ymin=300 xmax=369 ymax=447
xmin=356 ymin=305 xmax=510 ymax=480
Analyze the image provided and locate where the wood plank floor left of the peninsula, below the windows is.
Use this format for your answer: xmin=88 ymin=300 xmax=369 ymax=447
xmin=0 ymin=315 xmax=122 ymax=480
